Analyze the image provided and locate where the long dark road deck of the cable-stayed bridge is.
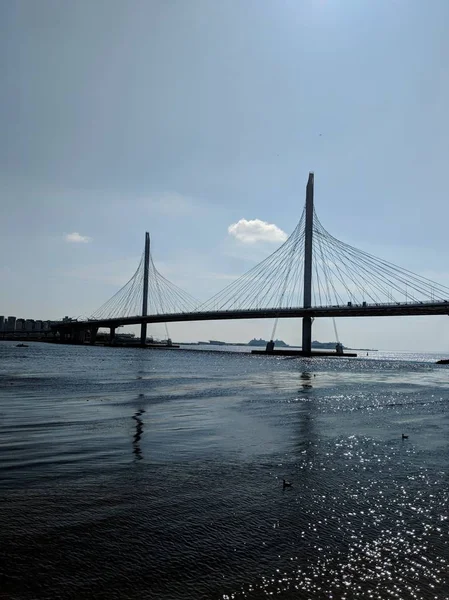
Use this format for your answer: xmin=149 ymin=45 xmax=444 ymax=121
xmin=52 ymin=301 xmax=449 ymax=332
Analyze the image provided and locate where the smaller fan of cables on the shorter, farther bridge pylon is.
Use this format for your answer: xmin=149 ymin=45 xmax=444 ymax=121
xmin=91 ymin=248 xmax=198 ymax=319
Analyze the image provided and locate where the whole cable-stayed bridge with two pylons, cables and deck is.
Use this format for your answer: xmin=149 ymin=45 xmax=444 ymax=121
xmin=53 ymin=173 xmax=449 ymax=355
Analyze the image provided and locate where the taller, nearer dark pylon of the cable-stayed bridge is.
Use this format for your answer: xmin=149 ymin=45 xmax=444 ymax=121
xmin=301 ymin=173 xmax=314 ymax=356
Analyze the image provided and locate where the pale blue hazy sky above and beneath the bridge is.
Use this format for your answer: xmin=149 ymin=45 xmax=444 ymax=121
xmin=0 ymin=0 xmax=449 ymax=351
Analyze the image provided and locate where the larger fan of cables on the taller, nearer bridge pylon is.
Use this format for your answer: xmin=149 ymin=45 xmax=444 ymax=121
xmin=198 ymin=210 xmax=449 ymax=311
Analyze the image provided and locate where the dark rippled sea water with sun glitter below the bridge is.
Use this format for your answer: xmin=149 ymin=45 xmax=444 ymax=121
xmin=0 ymin=342 xmax=449 ymax=600
